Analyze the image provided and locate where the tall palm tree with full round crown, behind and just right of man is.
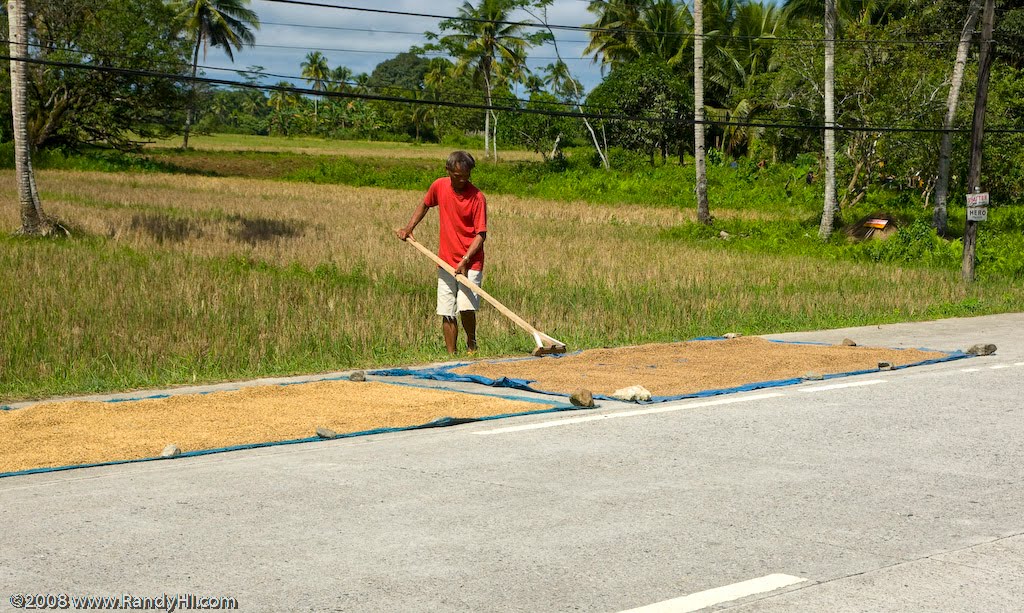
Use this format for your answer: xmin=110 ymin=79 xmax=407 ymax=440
xmin=427 ymin=0 xmax=543 ymax=160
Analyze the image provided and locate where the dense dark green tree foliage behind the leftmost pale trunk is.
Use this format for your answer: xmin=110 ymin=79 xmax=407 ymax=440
xmin=0 ymin=0 xmax=189 ymax=147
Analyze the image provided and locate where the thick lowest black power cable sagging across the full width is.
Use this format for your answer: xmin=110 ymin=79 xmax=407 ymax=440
xmin=0 ymin=55 xmax=1024 ymax=134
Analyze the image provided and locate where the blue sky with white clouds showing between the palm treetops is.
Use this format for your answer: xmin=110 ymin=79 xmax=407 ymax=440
xmin=200 ymin=0 xmax=601 ymax=90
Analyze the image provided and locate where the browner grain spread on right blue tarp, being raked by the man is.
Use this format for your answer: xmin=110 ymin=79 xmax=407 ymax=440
xmin=453 ymin=337 xmax=946 ymax=396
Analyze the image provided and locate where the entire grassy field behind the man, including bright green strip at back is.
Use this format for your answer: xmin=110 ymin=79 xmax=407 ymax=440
xmin=0 ymin=138 xmax=1024 ymax=402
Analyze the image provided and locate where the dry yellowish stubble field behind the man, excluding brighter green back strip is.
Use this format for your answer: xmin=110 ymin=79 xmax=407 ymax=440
xmin=0 ymin=137 xmax=1024 ymax=402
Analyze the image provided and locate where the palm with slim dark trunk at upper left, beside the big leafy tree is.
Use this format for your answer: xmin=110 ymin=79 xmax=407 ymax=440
xmin=169 ymin=0 xmax=259 ymax=148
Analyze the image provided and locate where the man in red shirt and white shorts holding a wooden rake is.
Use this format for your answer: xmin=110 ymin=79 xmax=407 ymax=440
xmin=396 ymin=151 xmax=487 ymax=354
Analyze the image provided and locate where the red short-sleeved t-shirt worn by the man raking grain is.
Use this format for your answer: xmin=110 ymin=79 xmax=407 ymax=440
xmin=423 ymin=177 xmax=487 ymax=270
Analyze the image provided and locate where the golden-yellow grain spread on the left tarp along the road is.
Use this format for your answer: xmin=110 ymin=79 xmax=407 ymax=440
xmin=0 ymin=381 xmax=551 ymax=473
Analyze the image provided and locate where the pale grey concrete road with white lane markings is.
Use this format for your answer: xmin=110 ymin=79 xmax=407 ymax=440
xmin=0 ymin=314 xmax=1024 ymax=613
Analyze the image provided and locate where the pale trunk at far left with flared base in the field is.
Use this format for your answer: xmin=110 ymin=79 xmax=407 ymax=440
xmin=7 ymin=0 xmax=46 ymax=235
